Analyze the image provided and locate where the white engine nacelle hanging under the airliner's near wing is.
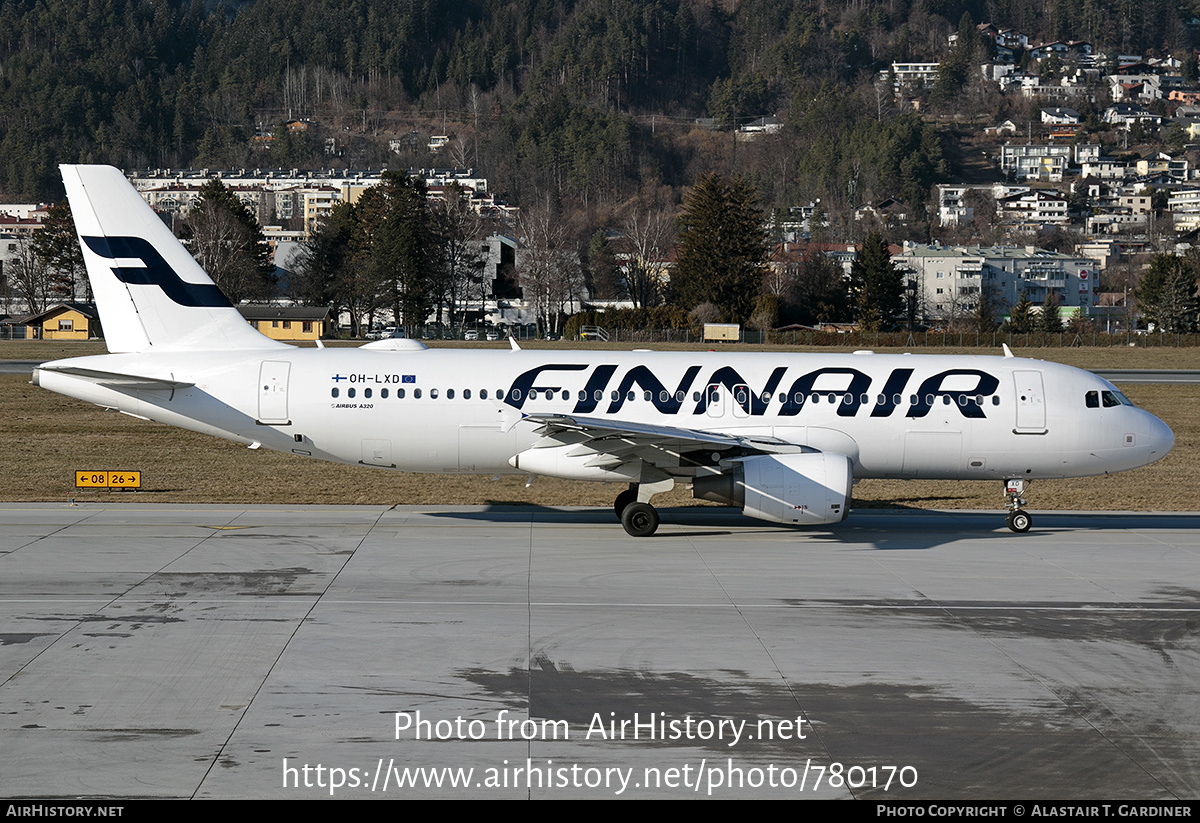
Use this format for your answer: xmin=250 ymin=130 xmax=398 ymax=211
xmin=692 ymin=451 xmax=854 ymax=525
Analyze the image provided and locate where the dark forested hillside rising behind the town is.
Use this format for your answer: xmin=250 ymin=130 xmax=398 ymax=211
xmin=0 ymin=0 xmax=1200 ymax=209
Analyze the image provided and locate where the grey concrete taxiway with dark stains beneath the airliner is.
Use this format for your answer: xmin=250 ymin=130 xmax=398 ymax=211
xmin=0 ymin=503 xmax=1200 ymax=799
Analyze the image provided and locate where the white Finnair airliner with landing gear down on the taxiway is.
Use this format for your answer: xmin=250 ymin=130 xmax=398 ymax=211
xmin=34 ymin=166 xmax=1175 ymax=536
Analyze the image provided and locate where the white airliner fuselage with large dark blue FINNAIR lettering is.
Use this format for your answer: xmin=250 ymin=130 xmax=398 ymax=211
xmin=35 ymin=348 xmax=1174 ymax=480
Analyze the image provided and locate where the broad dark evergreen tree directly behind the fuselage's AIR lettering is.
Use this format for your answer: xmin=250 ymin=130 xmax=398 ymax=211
xmin=671 ymin=172 xmax=768 ymax=323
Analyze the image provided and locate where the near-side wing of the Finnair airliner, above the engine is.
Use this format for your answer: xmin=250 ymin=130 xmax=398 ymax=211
xmin=524 ymin=414 xmax=816 ymax=467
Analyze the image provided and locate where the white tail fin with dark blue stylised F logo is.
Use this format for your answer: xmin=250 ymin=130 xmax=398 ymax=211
xmin=59 ymin=166 xmax=284 ymax=353
